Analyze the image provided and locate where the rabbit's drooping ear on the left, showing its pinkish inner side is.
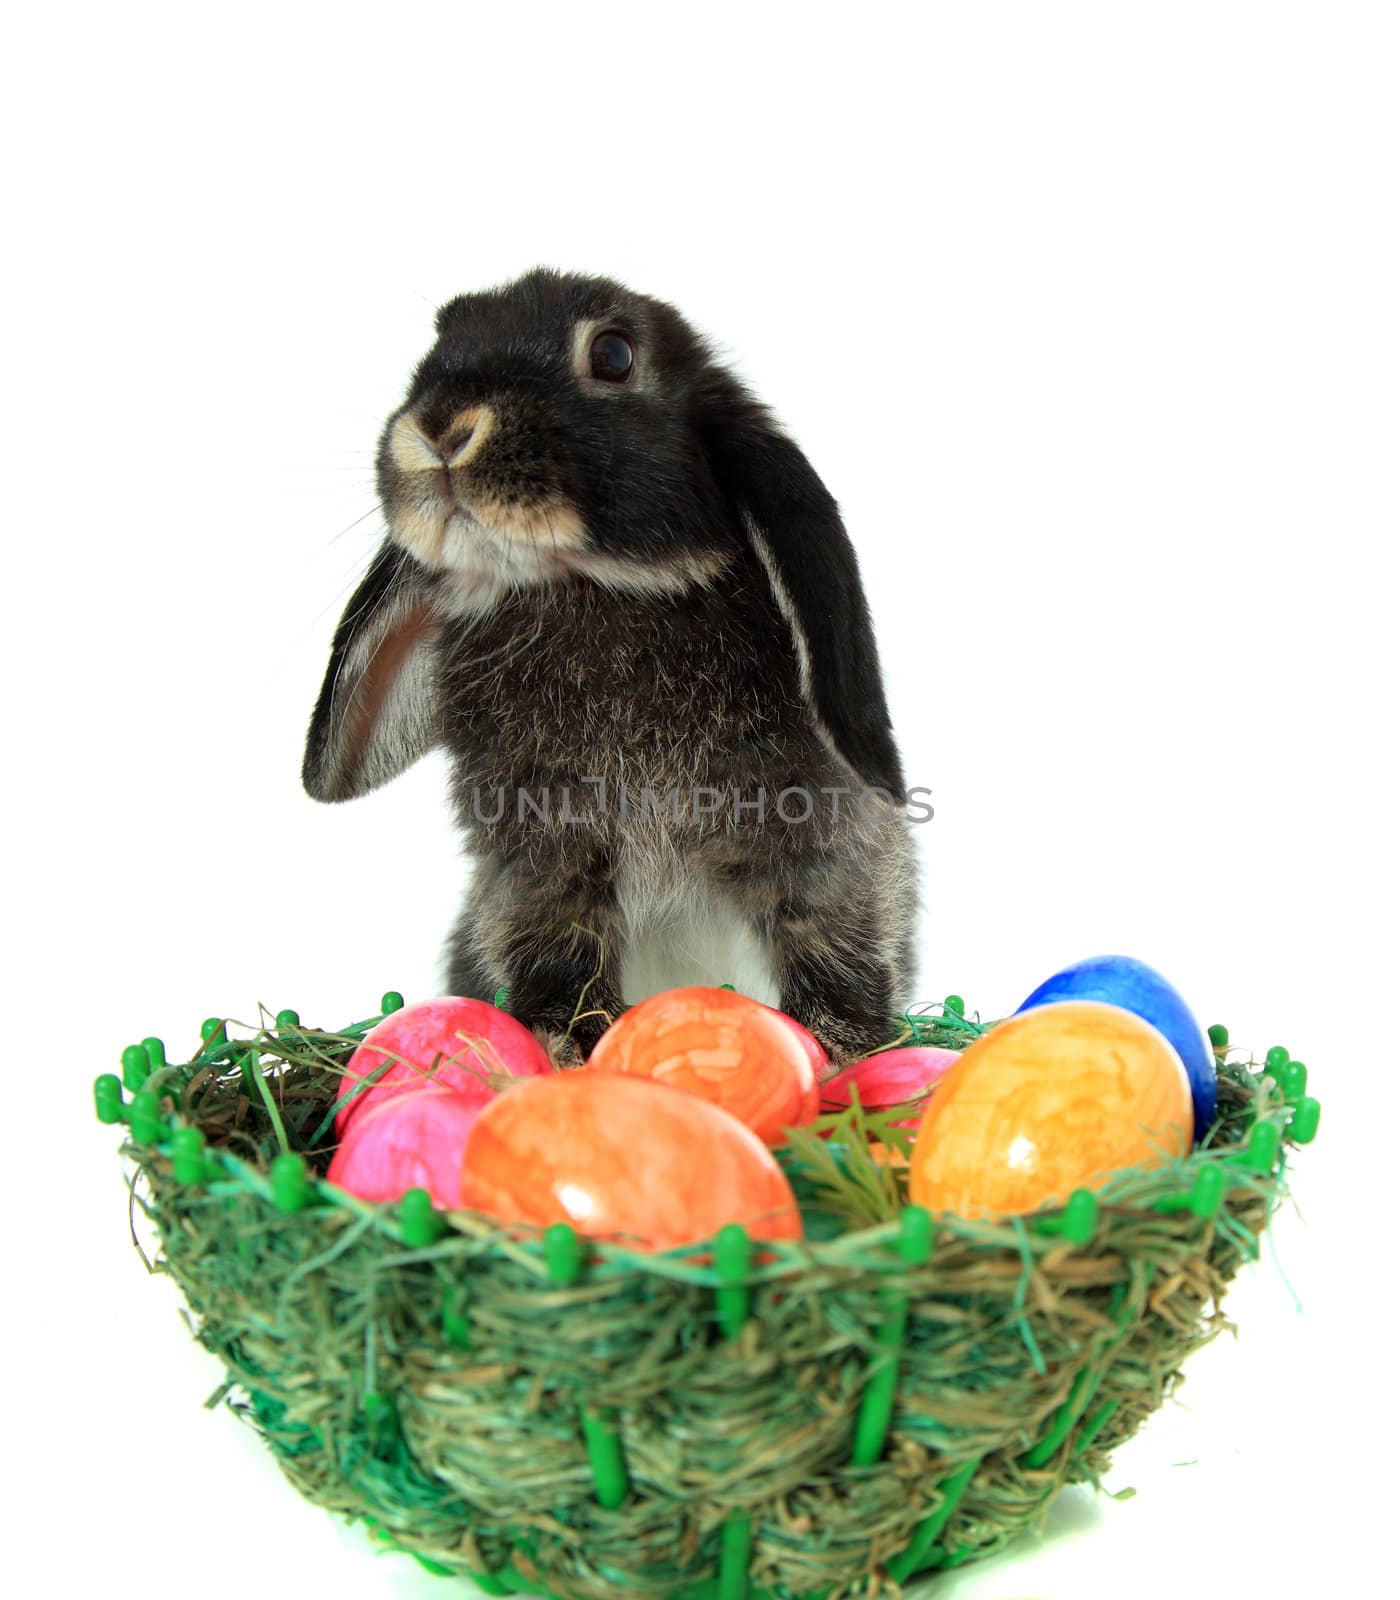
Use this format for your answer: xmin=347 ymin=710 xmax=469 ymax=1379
xmin=301 ymin=542 xmax=442 ymax=800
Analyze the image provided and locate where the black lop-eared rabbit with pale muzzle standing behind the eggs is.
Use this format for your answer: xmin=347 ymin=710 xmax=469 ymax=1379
xmin=302 ymin=269 xmax=917 ymax=1064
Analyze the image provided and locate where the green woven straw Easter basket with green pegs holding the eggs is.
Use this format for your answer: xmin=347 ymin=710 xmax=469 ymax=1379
xmin=96 ymin=995 xmax=1318 ymax=1600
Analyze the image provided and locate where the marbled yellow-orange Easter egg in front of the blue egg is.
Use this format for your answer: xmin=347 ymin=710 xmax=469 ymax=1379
xmin=909 ymin=1000 xmax=1190 ymax=1216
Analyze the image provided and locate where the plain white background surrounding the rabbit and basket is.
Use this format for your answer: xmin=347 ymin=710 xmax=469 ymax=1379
xmin=0 ymin=3 xmax=1400 ymax=1600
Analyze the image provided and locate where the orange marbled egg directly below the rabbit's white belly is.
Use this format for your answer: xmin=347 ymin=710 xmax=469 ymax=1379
xmin=587 ymin=989 xmax=818 ymax=1144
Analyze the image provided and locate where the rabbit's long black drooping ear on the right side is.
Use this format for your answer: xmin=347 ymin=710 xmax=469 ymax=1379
xmin=706 ymin=400 xmax=904 ymax=797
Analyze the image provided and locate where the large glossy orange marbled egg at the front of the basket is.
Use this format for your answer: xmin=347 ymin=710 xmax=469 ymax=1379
xmin=461 ymin=1072 xmax=802 ymax=1250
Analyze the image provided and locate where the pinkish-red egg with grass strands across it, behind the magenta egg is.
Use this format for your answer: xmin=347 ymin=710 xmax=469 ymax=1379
xmin=336 ymin=995 xmax=554 ymax=1138
